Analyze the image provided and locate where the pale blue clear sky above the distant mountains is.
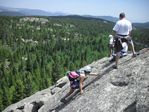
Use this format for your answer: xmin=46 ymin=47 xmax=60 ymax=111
xmin=0 ymin=0 xmax=149 ymax=23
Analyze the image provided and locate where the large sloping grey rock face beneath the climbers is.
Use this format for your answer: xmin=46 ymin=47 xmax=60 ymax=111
xmin=3 ymin=49 xmax=149 ymax=112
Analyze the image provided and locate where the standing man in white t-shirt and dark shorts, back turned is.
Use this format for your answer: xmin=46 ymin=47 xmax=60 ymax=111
xmin=113 ymin=13 xmax=136 ymax=69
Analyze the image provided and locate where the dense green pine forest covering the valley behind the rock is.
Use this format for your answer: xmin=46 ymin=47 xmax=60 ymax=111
xmin=0 ymin=16 xmax=149 ymax=111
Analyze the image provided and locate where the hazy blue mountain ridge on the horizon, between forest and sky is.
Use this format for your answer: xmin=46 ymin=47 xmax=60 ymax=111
xmin=0 ymin=6 xmax=149 ymax=28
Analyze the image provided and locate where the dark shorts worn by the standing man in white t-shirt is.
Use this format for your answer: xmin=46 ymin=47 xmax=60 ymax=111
xmin=115 ymin=36 xmax=132 ymax=53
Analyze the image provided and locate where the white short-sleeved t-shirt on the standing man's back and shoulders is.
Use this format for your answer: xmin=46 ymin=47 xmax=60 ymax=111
xmin=113 ymin=18 xmax=132 ymax=35
